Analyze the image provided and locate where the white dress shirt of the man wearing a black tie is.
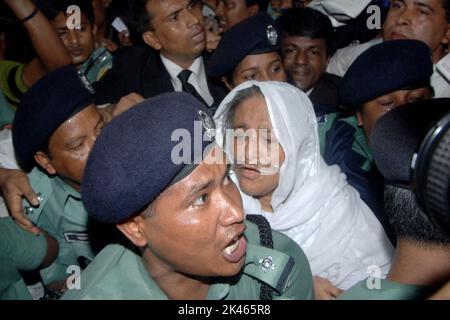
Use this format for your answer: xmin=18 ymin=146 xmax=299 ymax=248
xmin=160 ymin=54 xmax=214 ymax=106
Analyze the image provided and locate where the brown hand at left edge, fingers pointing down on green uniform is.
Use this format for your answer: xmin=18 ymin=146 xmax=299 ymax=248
xmin=0 ymin=168 xmax=40 ymax=235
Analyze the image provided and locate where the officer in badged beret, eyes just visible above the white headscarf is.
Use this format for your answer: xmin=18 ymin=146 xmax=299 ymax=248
xmin=207 ymin=13 xmax=287 ymax=90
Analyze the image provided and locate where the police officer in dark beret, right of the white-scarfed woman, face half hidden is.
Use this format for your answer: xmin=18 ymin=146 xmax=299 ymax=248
xmin=319 ymin=40 xmax=433 ymax=242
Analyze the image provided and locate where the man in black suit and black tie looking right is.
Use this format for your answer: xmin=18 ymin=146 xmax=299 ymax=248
xmin=94 ymin=0 xmax=227 ymax=112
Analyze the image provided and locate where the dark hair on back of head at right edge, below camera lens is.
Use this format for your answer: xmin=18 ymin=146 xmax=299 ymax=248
xmin=384 ymin=185 xmax=450 ymax=246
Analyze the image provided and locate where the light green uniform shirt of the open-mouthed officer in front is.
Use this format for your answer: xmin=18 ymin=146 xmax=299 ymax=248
xmin=62 ymin=222 xmax=314 ymax=300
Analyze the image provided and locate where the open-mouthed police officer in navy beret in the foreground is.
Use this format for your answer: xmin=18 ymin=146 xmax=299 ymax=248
xmin=63 ymin=93 xmax=313 ymax=300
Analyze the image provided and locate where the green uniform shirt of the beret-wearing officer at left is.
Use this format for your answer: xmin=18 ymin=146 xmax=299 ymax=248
xmin=26 ymin=168 xmax=95 ymax=284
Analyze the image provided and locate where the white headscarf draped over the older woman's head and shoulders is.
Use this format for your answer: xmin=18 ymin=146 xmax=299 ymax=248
xmin=214 ymin=81 xmax=392 ymax=289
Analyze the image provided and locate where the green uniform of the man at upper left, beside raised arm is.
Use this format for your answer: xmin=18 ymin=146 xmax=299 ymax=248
xmin=80 ymin=47 xmax=113 ymax=83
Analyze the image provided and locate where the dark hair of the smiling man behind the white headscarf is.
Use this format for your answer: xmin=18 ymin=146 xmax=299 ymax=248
xmin=279 ymin=8 xmax=334 ymax=55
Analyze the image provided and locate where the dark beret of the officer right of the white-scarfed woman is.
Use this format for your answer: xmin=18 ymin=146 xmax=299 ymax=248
xmin=339 ymin=40 xmax=433 ymax=109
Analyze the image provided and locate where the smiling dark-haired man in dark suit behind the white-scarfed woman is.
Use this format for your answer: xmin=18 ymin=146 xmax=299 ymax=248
xmin=280 ymin=8 xmax=341 ymax=117
